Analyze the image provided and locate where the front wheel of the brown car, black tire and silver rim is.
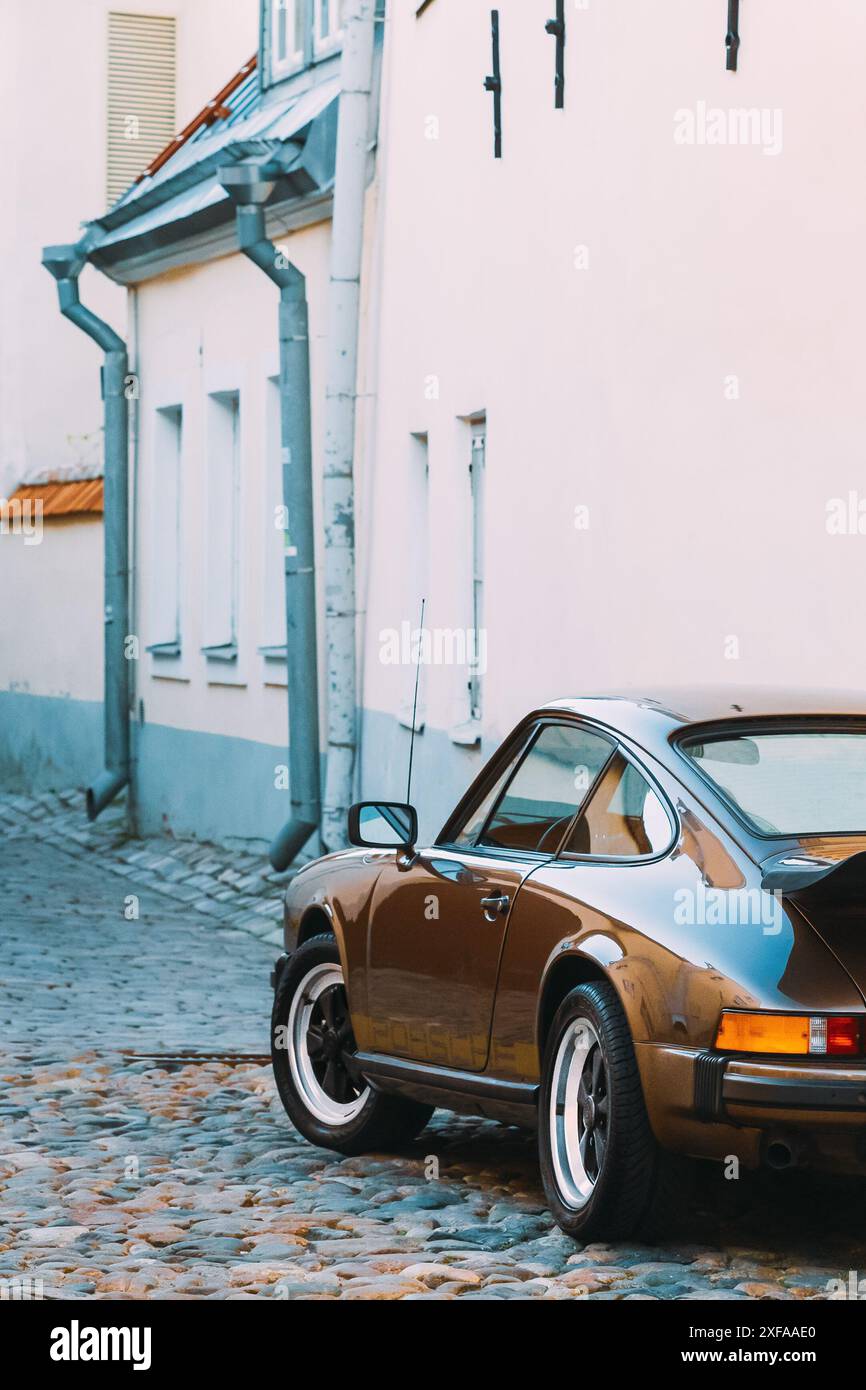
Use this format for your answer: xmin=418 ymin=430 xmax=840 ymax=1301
xmin=271 ymin=935 xmax=432 ymax=1155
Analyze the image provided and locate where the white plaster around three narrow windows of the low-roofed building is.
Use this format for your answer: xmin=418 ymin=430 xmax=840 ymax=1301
xmin=136 ymin=222 xmax=329 ymax=745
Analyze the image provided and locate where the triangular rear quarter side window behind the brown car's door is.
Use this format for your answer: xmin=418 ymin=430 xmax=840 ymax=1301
xmin=564 ymin=751 xmax=673 ymax=859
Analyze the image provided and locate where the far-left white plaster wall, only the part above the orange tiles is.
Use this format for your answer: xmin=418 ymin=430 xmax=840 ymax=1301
xmin=0 ymin=0 xmax=259 ymax=496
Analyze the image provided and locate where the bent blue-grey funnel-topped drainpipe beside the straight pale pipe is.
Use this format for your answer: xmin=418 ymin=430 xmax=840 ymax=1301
xmin=220 ymin=164 xmax=321 ymax=872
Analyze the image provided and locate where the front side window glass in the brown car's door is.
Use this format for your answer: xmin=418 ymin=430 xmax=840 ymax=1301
xmin=478 ymin=724 xmax=613 ymax=853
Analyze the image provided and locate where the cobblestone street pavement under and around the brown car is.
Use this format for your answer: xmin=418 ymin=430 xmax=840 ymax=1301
xmin=0 ymin=816 xmax=866 ymax=1300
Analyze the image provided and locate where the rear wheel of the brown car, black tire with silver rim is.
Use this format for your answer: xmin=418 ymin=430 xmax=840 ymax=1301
xmin=538 ymin=981 xmax=692 ymax=1243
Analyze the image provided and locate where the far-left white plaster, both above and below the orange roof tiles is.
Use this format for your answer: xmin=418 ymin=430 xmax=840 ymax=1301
xmin=0 ymin=0 xmax=259 ymax=699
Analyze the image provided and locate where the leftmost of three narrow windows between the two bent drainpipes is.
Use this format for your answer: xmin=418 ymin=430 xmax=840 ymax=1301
xmin=147 ymin=406 xmax=183 ymax=657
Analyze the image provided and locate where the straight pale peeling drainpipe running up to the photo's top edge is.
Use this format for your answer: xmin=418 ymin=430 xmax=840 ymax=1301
xmin=322 ymin=0 xmax=377 ymax=849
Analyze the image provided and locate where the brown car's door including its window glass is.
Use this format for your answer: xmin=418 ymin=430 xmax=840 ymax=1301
xmin=367 ymin=720 xmax=613 ymax=1072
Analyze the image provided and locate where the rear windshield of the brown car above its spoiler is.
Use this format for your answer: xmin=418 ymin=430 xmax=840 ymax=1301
xmin=681 ymin=730 xmax=866 ymax=835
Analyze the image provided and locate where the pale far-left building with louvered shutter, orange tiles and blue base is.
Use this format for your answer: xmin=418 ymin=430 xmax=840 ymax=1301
xmin=0 ymin=0 xmax=259 ymax=791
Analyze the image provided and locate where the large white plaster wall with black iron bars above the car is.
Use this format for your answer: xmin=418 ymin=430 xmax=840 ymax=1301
xmin=364 ymin=0 xmax=866 ymax=767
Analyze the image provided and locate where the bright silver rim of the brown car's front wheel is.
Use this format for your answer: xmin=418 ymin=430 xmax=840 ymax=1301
xmin=286 ymin=963 xmax=370 ymax=1125
